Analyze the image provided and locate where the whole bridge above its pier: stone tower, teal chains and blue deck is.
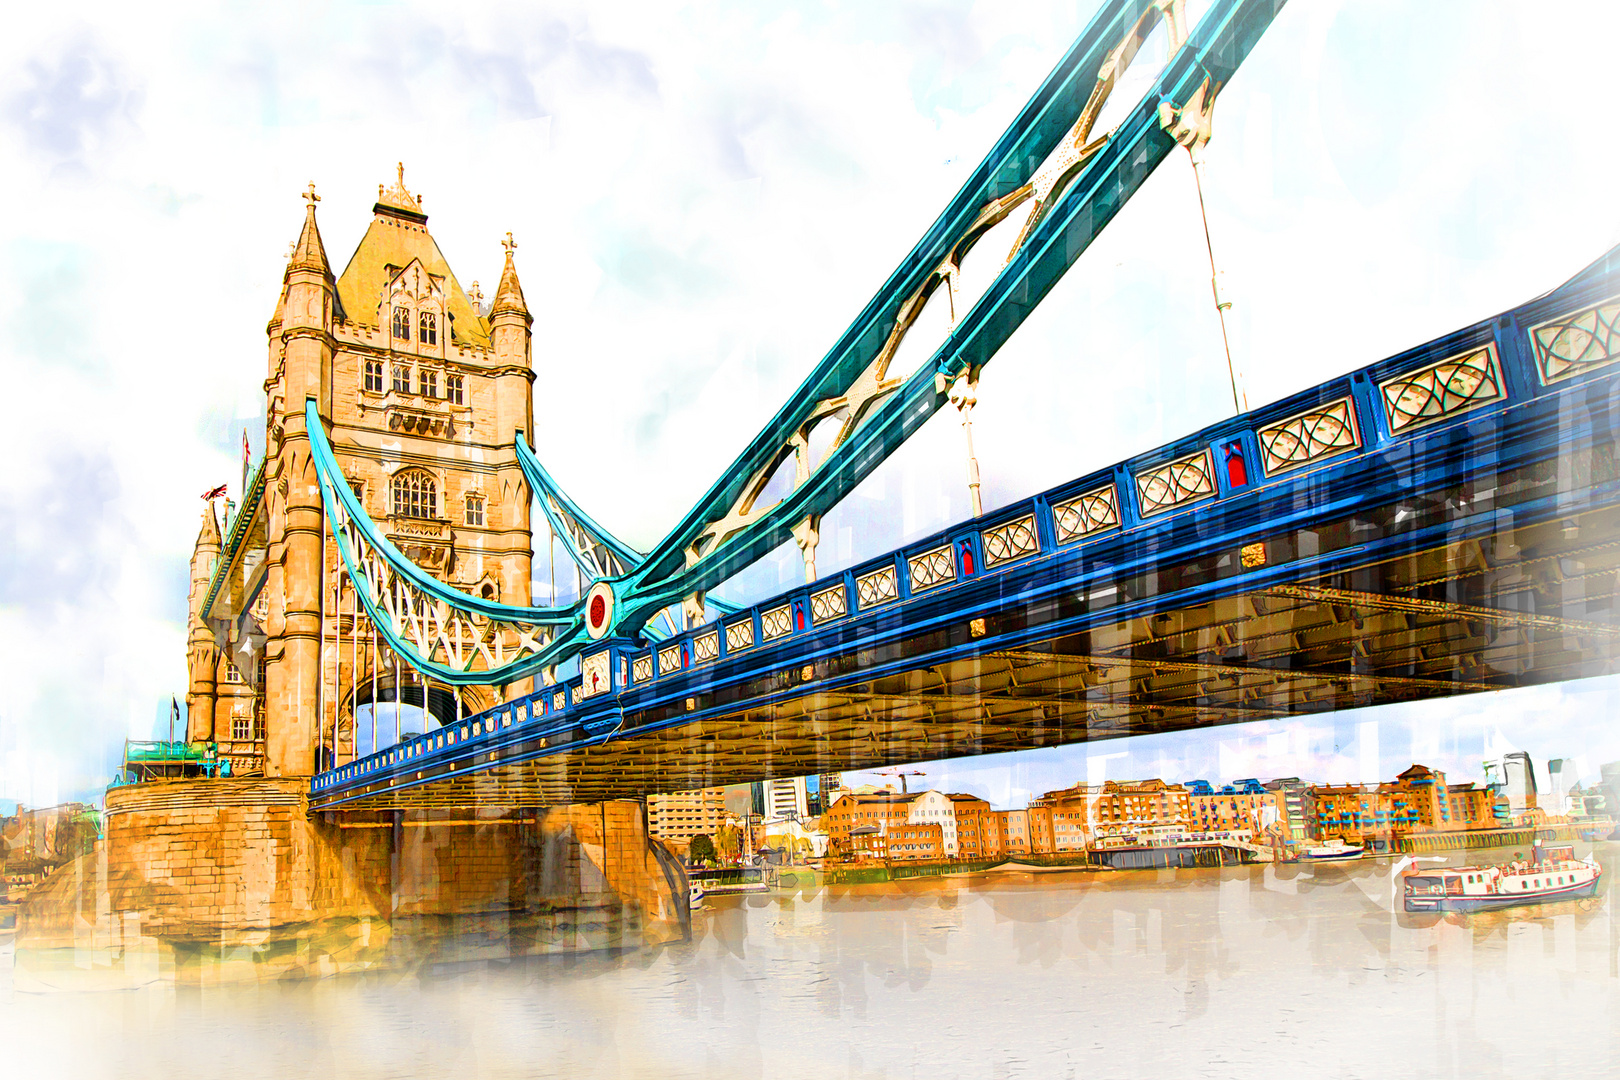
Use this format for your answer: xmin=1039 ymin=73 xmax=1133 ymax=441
xmin=177 ymin=0 xmax=1620 ymax=810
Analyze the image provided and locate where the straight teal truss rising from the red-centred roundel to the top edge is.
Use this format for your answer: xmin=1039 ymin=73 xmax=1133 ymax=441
xmin=599 ymin=0 xmax=1281 ymax=635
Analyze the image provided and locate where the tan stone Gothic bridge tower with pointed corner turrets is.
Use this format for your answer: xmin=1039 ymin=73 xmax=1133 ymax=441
xmin=193 ymin=167 xmax=535 ymax=776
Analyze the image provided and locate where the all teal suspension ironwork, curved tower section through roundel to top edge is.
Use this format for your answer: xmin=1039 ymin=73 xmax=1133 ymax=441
xmin=309 ymin=0 xmax=1281 ymax=683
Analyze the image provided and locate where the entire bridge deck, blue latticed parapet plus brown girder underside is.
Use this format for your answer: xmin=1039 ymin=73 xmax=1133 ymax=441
xmin=311 ymin=249 xmax=1620 ymax=810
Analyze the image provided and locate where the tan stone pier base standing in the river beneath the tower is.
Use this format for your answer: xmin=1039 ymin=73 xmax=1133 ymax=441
xmin=15 ymin=779 xmax=690 ymax=991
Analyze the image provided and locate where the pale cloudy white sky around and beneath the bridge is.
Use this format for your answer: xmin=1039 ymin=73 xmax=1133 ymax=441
xmin=0 ymin=0 xmax=1620 ymax=805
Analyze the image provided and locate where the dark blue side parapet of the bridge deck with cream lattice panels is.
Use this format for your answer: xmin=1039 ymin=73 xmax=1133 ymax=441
xmin=313 ymin=248 xmax=1620 ymax=805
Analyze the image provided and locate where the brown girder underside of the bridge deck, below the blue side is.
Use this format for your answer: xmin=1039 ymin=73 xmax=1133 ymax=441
xmin=313 ymin=485 xmax=1620 ymax=806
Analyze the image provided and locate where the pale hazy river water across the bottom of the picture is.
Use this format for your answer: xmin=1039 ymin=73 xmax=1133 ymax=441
xmin=0 ymin=844 xmax=1620 ymax=1080
